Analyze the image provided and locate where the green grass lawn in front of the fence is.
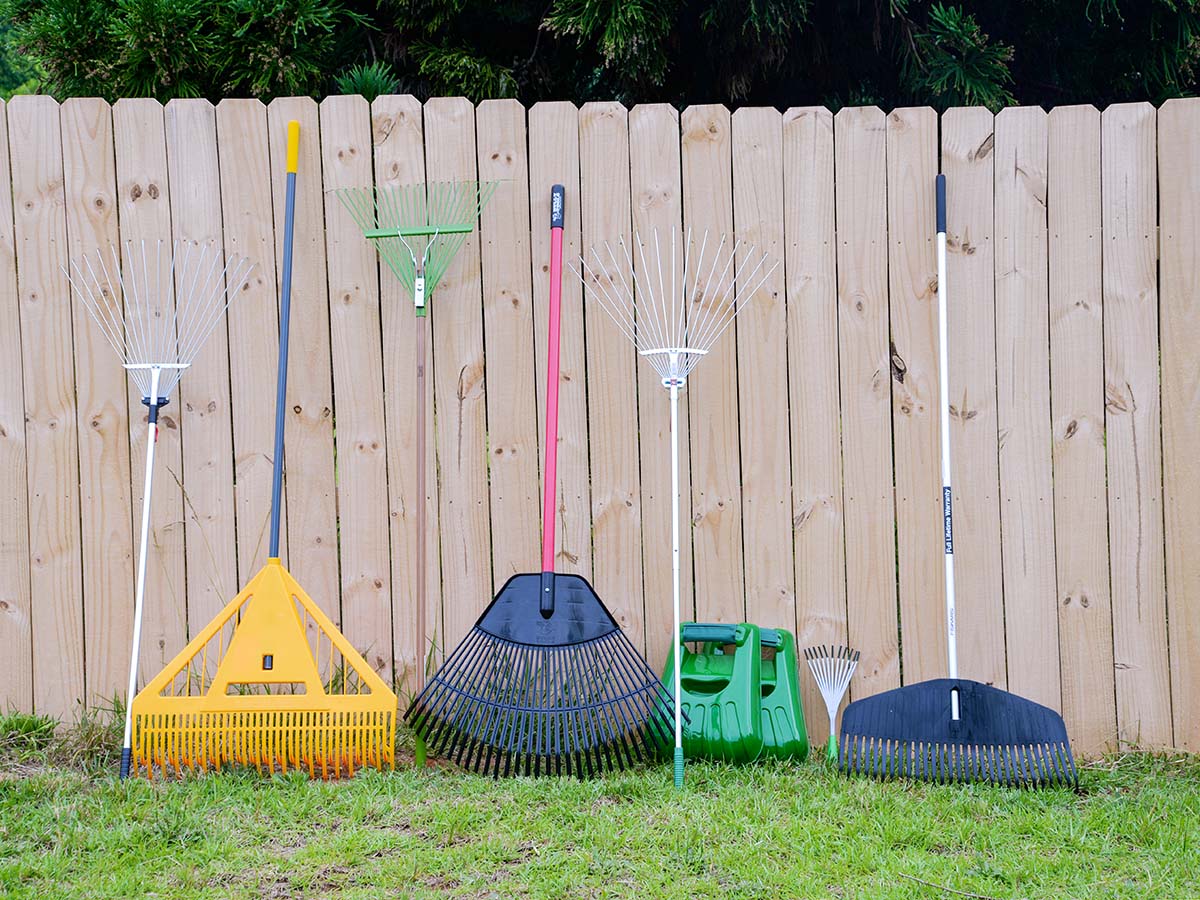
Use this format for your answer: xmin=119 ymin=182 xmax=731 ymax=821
xmin=0 ymin=716 xmax=1200 ymax=900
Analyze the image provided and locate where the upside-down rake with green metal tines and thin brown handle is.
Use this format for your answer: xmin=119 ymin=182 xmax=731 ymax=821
xmin=337 ymin=181 xmax=499 ymax=766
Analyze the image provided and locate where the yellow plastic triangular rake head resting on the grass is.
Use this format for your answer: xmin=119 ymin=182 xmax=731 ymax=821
xmin=132 ymin=559 xmax=396 ymax=778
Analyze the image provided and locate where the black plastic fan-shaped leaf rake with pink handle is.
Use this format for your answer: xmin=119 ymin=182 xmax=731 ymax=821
xmin=406 ymin=185 xmax=671 ymax=778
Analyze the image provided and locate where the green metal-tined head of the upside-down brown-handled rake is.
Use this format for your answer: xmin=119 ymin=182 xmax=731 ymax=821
xmin=337 ymin=181 xmax=499 ymax=316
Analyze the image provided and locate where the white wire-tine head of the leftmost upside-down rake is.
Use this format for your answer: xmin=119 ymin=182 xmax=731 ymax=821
xmin=65 ymin=240 xmax=254 ymax=401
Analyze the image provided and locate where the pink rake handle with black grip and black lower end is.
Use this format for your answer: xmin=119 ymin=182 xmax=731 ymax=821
xmin=541 ymin=185 xmax=566 ymax=619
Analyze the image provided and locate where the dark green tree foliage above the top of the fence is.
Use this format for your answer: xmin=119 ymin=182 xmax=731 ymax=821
xmin=0 ymin=0 xmax=1200 ymax=109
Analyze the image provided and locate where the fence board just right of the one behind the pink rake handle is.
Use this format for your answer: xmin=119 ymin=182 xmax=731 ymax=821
xmin=578 ymin=103 xmax=648 ymax=647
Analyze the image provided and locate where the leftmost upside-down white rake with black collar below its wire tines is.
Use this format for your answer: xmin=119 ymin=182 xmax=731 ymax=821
xmin=65 ymin=241 xmax=254 ymax=779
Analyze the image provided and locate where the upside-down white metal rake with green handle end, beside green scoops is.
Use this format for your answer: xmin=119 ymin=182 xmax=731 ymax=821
xmin=575 ymin=230 xmax=778 ymax=787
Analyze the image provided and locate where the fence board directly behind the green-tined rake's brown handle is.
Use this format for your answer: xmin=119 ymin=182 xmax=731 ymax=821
xmin=371 ymin=95 xmax=443 ymax=691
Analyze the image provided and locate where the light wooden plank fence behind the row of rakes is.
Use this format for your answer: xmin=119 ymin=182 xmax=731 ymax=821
xmin=0 ymin=96 xmax=1200 ymax=752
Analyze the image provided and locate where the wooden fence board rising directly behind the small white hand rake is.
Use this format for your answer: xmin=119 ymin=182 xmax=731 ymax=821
xmin=784 ymin=107 xmax=847 ymax=745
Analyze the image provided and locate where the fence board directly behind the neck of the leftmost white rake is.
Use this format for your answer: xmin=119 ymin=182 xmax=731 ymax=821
xmin=113 ymin=100 xmax=187 ymax=680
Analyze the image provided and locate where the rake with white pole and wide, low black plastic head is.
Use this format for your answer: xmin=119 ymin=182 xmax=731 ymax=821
xmin=839 ymin=175 xmax=1079 ymax=787
